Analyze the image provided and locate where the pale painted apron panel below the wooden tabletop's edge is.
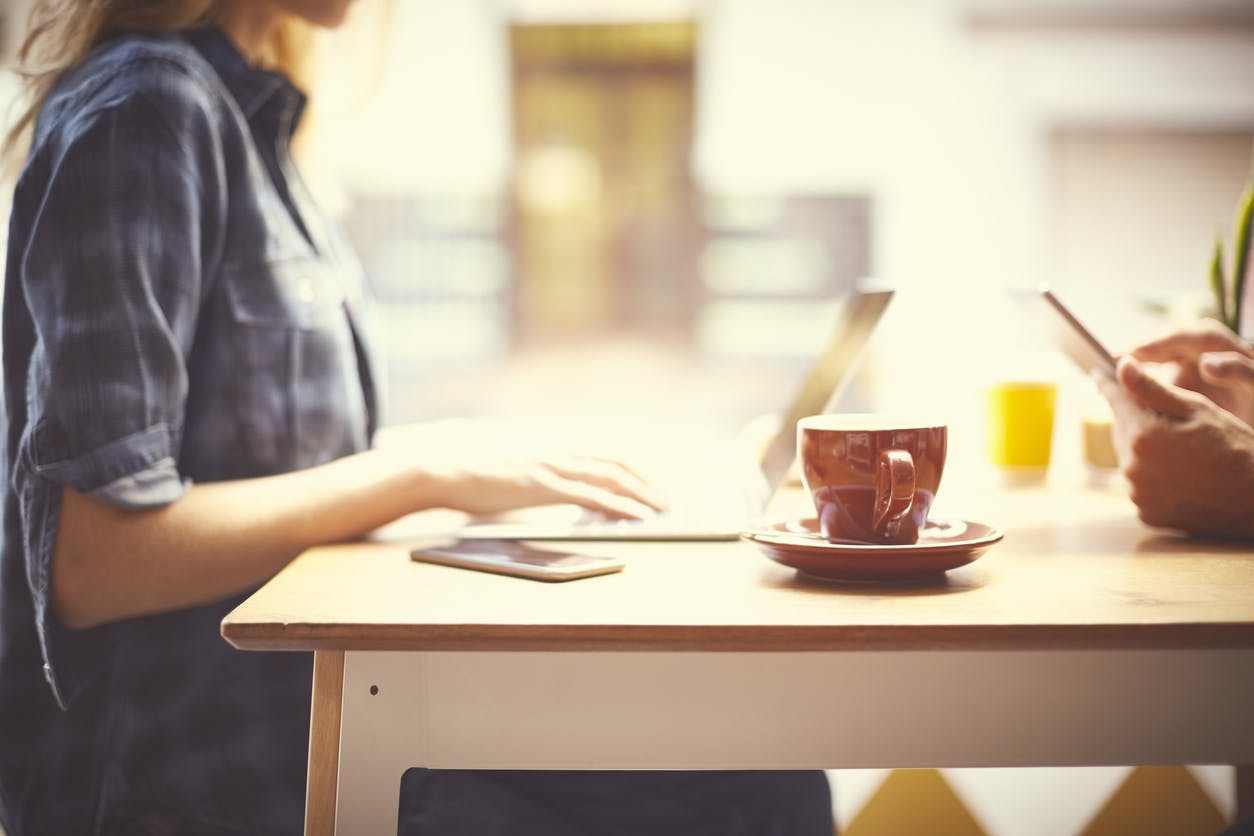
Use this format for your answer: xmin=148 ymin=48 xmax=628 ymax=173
xmin=337 ymin=649 xmax=1254 ymax=832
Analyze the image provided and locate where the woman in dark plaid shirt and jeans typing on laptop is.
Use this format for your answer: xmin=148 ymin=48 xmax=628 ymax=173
xmin=0 ymin=0 xmax=833 ymax=836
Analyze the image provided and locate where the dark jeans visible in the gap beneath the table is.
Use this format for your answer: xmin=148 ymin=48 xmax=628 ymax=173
xmin=400 ymin=768 xmax=835 ymax=836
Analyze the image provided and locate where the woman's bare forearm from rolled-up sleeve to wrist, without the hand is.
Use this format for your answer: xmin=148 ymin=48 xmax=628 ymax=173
xmin=51 ymin=450 xmax=438 ymax=628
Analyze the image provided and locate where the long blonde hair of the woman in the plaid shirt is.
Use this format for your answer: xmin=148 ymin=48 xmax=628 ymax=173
xmin=0 ymin=0 xmax=312 ymax=166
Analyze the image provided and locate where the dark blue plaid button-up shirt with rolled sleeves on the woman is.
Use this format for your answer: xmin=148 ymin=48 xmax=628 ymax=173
xmin=0 ymin=29 xmax=377 ymax=836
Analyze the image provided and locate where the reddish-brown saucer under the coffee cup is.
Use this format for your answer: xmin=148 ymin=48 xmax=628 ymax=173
xmin=741 ymin=519 xmax=1003 ymax=582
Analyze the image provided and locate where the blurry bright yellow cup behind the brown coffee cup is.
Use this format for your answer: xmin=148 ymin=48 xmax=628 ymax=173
xmin=988 ymin=381 xmax=1058 ymax=478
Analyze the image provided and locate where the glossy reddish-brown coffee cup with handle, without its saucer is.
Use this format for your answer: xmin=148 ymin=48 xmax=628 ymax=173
xmin=796 ymin=415 xmax=948 ymax=545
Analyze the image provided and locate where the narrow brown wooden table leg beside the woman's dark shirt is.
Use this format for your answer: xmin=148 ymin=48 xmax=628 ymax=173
xmin=305 ymin=651 xmax=344 ymax=836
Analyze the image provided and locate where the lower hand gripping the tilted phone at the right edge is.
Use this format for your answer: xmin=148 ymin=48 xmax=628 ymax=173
xmin=1099 ymin=355 xmax=1254 ymax=538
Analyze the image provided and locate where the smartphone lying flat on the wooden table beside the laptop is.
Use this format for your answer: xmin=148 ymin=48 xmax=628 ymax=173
xmin=410 ymin=540 xmax=626 ymax=580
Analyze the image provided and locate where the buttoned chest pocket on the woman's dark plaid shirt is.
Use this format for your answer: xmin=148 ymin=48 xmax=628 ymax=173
xmin=217 ymin=257 xmax=362 ymax=473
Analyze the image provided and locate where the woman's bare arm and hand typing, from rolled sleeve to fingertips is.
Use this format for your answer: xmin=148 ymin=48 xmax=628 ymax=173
xmin=53 ymin=421 xmax=661 ymax=628
